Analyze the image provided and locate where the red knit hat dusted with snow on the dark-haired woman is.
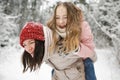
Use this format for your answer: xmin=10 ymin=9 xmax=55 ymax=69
xmin=20 ymin=22 xmax=45 ymax=47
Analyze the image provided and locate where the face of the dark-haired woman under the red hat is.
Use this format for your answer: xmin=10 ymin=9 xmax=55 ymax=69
xmin=23 ymin=39 xmax=35 ymax=57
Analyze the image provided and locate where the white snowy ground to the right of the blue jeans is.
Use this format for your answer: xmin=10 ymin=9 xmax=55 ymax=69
xmin=95 ymin=49 xmax=120 ymax=80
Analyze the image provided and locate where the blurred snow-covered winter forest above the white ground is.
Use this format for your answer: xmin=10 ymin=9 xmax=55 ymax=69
xmin=0 ymin=0 xmax=120 ymax=71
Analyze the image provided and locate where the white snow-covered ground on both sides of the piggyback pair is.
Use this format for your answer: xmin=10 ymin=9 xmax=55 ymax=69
xmin=0 ymin=46 xmax=120 ymax=80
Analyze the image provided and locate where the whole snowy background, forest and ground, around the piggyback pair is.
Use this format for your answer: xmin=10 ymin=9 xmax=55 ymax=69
xmin=0 ymin=0 xmax=120 ymax=80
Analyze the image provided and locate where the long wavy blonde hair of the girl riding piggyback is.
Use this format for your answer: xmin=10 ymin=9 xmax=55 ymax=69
xmin=47 ymin=2 xmax=83 ymax=53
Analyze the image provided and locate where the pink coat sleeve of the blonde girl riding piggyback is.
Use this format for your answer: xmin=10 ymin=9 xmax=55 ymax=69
xmin=78 ymin=21 xmax=96 ymax=59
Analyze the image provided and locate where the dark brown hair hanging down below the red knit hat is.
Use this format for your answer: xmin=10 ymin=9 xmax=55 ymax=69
xmin=22 ymin=40 xmax=45 ymax=72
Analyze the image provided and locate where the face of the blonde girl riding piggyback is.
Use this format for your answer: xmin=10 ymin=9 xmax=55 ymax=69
xmin=56 ymin=5 xmax=67 ymax=29
